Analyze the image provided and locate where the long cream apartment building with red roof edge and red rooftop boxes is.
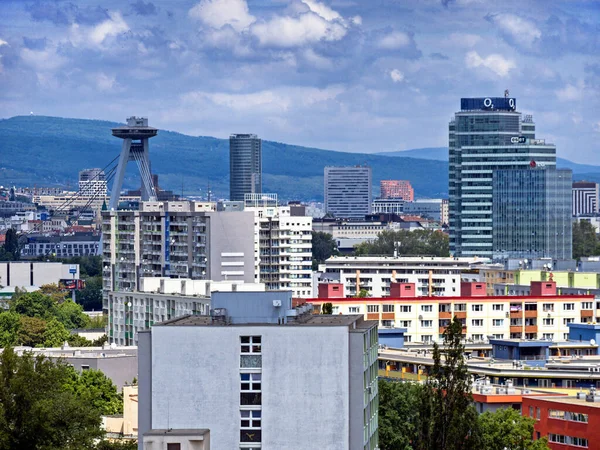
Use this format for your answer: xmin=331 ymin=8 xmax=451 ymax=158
xmin=307 ymin=281 xmax=600 ymax=343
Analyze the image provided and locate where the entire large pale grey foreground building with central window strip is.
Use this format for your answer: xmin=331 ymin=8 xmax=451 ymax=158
xmin=138 ymin=292 xmax=378 ymax=450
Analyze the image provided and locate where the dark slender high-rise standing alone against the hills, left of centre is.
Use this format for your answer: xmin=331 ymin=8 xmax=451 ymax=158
xmin=229 ymin=134 xmax=262 ymax=201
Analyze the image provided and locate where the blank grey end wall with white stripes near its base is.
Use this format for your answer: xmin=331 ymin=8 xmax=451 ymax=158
xmin=206 ymin=211 xmax=254 ymax=283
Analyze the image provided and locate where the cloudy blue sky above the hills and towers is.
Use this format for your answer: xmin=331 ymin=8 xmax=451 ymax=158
xmin=0 ymin=0 xmax=600 ymax=164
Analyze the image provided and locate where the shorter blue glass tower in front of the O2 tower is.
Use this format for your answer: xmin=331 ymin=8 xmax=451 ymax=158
xmin=492 ymin=168 xmax=573 ymax=260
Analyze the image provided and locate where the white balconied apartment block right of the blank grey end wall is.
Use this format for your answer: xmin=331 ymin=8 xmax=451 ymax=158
xmin=245 ymin=202 xmax=312 ymax=298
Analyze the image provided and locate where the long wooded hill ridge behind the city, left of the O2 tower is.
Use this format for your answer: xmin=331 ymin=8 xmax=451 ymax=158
xmin=0 ymin=116 xmax=448 ymax=201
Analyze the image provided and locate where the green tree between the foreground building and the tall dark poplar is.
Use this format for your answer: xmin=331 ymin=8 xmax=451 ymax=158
xmin=379 ymin=380 xmax=423 ymax=450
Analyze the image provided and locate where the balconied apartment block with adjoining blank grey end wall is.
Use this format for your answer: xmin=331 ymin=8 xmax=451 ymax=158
xmin=102 ymin=201 xmax=255 ymax=311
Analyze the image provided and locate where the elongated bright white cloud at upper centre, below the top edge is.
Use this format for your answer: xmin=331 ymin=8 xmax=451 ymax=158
xmin=251 ymin=12 xmax=347 ymax=47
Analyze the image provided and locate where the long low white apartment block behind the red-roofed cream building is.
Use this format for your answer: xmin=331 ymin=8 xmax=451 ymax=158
xmin=322 ymin=256 xmax=477 ymax=297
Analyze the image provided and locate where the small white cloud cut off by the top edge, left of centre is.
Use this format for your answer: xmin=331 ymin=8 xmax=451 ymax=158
xmin=188 ymin=0 xmax=256 ymax=31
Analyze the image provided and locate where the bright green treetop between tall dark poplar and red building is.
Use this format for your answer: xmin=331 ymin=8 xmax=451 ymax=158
xmin=479 ymin=408 xmax=549 ymax=450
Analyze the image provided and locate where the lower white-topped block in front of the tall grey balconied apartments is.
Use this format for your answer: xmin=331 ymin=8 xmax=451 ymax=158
xmin=107 ymin=277 xmax=265 ymax=345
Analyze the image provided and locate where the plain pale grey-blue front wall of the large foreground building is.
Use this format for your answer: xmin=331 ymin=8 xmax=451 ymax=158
xmin=150 ymin=326 xmax=354 ymax=450
